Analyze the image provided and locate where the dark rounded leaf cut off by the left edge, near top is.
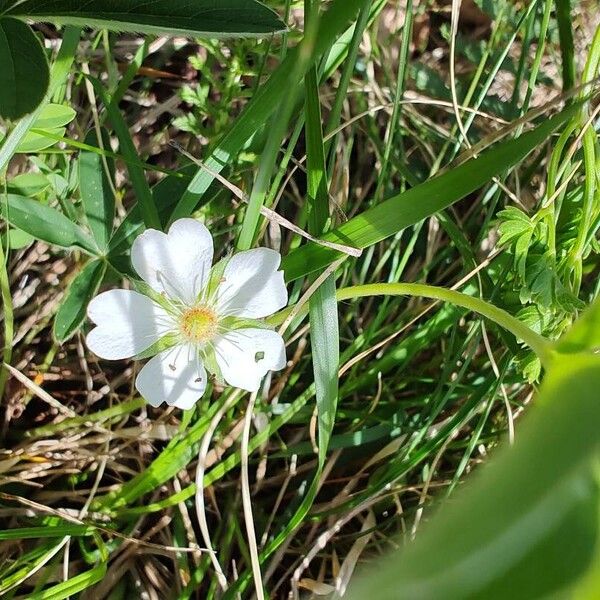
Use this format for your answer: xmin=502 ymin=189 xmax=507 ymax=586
xmin=0 ymin=17 xmax=50 ymax=120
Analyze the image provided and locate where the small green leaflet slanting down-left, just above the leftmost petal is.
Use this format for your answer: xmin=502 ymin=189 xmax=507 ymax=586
xmin=54 ymin=260 xmax=106 ymax=344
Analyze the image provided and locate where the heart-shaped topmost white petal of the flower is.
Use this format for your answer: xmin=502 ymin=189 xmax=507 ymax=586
xmin=131 ymin=219 xmax=213 ymax=304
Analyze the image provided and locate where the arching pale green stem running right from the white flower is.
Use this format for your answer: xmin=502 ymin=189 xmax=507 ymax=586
xmin=268 ymin=283 xmax=550 ymax=363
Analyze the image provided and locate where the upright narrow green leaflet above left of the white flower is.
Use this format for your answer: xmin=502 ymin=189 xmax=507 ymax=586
xmin=79 ymin=129 xmax=115 ymax=250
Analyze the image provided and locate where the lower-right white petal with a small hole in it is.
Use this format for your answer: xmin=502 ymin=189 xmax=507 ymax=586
xmin=214 ymin=329 xmax=286 ymax=392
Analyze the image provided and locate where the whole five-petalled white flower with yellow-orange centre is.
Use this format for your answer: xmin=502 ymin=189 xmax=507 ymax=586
xmin=86 ymin=219 xmax=287 ymax=409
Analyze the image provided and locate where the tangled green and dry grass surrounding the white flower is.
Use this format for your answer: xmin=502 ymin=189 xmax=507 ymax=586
xmin=0 ymin=0 xmax=600 ymax=600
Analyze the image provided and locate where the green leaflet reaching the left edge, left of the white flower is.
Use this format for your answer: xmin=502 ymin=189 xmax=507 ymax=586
xmin=0 ymin=194 xmax=98 ymax=254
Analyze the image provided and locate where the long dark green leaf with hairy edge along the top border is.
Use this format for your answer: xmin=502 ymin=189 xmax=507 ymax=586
xmin=0 ymin=0 xmax=285 ymax=38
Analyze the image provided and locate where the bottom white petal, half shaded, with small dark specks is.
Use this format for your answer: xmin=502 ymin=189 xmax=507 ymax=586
xmin=135 ymin=345 xmax=206 ymax=410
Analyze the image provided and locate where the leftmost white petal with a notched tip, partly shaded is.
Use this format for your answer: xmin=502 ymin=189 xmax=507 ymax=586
xmin=86 ymin=290 xmax=174 ymax=360
